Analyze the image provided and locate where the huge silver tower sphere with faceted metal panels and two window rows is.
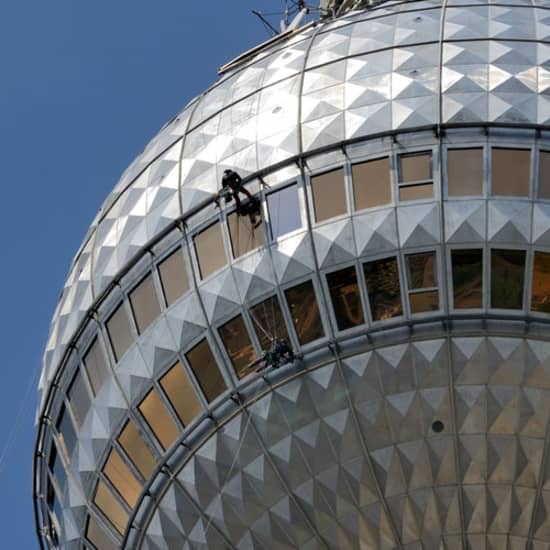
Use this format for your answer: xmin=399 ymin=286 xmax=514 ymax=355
xmin=33 ymin=0 xmax=550 ymax=550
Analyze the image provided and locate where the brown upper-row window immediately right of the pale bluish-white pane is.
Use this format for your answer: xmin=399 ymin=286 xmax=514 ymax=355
xmin=311 ymin=168 xmax=348 ymax=222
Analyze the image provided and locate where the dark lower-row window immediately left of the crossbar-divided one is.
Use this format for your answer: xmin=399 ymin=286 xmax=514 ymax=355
xmin=363 ymin=258 xmax=403 ymax=321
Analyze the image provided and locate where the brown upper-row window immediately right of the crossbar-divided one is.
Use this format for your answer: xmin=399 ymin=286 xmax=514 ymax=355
xmin=447 ymin=148 xmax=483 ymax=197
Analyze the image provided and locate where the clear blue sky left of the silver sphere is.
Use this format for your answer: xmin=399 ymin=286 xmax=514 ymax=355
xmin=0 ymin=0 xmax=284 ymax=550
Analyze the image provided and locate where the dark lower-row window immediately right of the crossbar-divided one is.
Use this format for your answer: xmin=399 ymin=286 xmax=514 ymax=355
xmin=451 ymin=248 xmax=483 ymax=309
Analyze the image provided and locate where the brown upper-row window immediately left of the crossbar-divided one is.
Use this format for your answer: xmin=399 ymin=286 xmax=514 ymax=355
xmin=351 ymin=158 xmax=391 ymax=210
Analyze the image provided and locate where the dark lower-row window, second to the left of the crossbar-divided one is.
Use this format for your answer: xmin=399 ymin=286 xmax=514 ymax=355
xmin=327 ymin=267 xmax=365 ymax=330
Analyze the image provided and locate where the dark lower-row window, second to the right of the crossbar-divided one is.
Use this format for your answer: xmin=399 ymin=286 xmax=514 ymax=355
xmin=491 ymin=249 xmax=525 ymax=309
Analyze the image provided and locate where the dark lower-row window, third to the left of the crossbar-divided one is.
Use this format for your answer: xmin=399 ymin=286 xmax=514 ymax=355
xmin=285 ymin=281 xmax=325 ymax=345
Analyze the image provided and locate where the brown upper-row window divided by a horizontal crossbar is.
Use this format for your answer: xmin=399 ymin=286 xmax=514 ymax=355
xmin=399 ymin=152 xmax=433 ymax=201
